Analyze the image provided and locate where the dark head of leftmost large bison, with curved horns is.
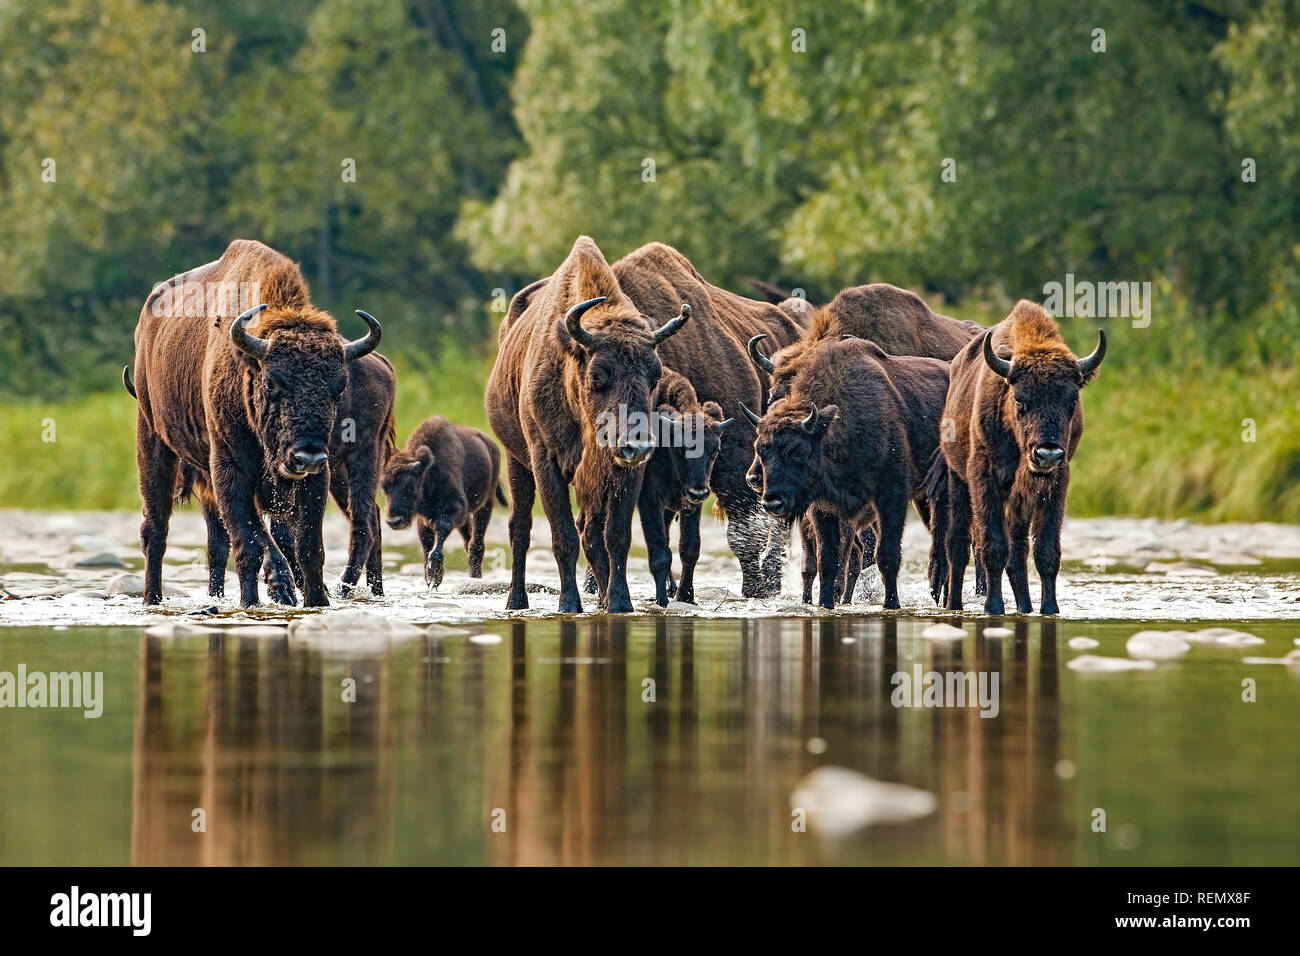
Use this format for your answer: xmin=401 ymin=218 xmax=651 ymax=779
xmin=230 ymin=304 xmax=382 ymax=480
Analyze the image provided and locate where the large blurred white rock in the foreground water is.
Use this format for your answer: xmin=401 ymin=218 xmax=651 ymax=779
xmin=790 ymin=766 xmax=937 ymax=836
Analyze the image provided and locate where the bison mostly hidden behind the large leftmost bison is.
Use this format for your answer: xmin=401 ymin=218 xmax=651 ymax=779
xmin=122 ymin=352 xmax=397 ymax=597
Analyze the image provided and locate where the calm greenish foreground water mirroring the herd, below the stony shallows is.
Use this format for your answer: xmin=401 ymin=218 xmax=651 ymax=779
xmin=0 ymin=617 xmax=1300 ymax=865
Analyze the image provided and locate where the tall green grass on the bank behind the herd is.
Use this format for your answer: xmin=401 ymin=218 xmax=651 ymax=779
xmin=0 ymin=302 xmax=1300 ymax=522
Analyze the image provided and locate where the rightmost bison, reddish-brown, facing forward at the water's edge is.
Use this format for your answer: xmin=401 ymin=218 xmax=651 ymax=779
xmin=943 ymin=300 xmax=1106 ymax=614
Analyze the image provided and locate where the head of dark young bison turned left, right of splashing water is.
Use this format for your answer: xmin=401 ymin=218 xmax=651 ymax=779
xmin=741 ymin=398 xmax=840 ymax=519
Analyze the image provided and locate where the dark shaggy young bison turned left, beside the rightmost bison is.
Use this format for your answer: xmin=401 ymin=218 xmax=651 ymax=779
xmin=742 ymin=339 xmax=948 ymax=609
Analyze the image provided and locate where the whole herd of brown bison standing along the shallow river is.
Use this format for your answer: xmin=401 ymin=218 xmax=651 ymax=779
xmin=124 ymin=237 xmax=1106 ymax=614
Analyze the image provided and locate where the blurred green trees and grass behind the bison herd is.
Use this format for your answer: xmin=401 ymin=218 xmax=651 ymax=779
xmin=0 ymin=0 xmax=1300 ymax=520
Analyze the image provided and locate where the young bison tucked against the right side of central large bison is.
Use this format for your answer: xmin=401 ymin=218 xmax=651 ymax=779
xmin=637 ymin=368 xmax=732 ymax=606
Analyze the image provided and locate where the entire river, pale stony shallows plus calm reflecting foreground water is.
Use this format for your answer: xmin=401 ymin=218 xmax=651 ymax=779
xmin=0 ymin=511 xmax=1300 ymax=865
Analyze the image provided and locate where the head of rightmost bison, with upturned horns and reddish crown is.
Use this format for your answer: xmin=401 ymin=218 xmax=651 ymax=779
xmin=984 ymin=329 xmax=1106 ymax=475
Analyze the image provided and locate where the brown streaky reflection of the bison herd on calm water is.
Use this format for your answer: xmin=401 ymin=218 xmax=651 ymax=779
xmin=124 ymin=617 xmax=1087 ymax=865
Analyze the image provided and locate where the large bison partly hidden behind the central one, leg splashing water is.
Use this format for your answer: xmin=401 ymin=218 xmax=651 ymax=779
xmin=614 ymin=242 xmax=802 ymax=597
